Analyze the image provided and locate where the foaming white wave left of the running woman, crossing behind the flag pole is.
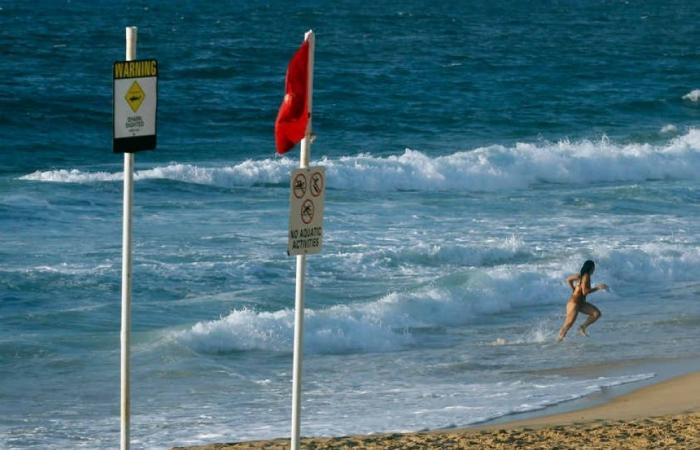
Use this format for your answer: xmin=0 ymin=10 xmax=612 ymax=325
xmin=174 ymin=269 xmax=558 ymax=353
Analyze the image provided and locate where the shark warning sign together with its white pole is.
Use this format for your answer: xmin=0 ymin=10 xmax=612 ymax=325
xmin=112 ymin=27 xmax=158 ymax=450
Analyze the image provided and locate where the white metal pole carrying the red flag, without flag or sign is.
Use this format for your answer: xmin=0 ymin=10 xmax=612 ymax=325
xmin=291 ymin=30 xmax=314 ymax=450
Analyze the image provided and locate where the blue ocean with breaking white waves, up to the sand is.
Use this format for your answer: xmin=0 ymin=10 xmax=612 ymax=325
xmin=0 ymin=0 xmax=700 ymax=449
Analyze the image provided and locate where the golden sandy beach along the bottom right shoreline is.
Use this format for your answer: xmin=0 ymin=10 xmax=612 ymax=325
xmin=176 ymin=372 xmax=700 ymax=450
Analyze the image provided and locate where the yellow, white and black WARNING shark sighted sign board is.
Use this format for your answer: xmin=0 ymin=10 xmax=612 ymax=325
xmin=112 ymin=59 xmax=158 ymax=153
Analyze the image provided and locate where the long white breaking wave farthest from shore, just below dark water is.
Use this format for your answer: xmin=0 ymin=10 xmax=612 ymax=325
xmin=21 ymin=130 xmax=700 ymax=191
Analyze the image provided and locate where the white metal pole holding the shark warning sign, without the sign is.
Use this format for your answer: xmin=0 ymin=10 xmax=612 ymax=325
xmin=121 ymin=27 xmax=137 ymax=450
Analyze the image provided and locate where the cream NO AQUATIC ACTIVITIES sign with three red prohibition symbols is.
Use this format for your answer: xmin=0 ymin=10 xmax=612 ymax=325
xmin=287 ymin=167 xmax=326 ymax=255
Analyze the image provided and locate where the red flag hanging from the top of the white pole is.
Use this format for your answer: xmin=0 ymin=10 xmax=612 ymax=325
xmin=275 ymin=41 xmax=309 ymax=153
